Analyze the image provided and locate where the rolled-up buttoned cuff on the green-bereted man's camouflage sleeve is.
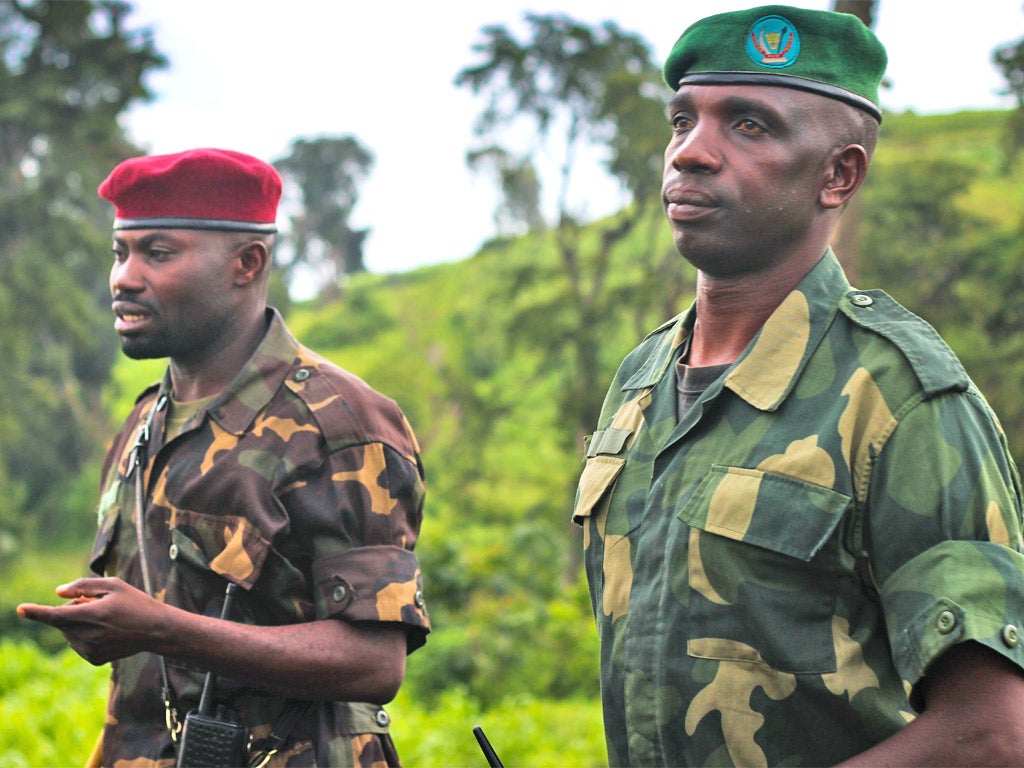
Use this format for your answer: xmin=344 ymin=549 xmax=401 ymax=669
xmin=881 ymin=541 xmax=1024 ymax=696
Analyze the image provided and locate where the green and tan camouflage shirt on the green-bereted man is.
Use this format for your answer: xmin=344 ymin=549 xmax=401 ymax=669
xmin=573 ymin=251 xmax=1024 ymax=766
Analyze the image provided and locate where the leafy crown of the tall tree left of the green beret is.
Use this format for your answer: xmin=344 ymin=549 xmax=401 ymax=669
xmin=456 ymin=13 xmax=665 ymax=230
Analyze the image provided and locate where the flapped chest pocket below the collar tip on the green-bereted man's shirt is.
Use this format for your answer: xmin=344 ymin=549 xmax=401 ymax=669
xmin=677 ymin=466 xmax=850 ymax=674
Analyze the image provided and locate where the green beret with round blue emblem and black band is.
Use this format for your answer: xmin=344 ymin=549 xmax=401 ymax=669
xmin=663 ymin=5 xmax=886 ymax=122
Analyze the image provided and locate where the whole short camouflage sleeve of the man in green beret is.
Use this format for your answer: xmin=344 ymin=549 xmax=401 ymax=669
xmin=867 ymin=391 xmax=1024 ymax=696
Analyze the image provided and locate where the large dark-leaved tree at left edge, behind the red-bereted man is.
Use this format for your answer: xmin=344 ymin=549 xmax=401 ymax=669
xmin=0 ymin=0 xmax=166 ymax=549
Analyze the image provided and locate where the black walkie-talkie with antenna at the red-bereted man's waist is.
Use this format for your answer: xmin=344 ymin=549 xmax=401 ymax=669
xmin=177 ymin=583 xmax=249 ymax=768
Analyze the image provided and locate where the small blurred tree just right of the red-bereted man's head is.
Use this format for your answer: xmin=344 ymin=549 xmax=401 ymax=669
xmin=274 ymin=136 xmax=374 ymax=292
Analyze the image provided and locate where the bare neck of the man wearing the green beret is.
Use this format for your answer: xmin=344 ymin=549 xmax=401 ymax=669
xmin=689 ymin=249 xmax=824 ymax=366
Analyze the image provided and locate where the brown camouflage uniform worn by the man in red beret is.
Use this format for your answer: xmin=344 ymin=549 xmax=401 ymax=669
xmin=86 ymin=310 xmax=430 ymax=768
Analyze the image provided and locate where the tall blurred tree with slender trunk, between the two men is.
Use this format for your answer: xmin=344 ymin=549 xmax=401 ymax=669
xmin=456 ymin=13 xmax=667 ymax=444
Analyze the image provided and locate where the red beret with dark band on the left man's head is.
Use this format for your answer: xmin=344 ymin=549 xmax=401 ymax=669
xmin=97 ymin=148 xmax=281 ymax=232
